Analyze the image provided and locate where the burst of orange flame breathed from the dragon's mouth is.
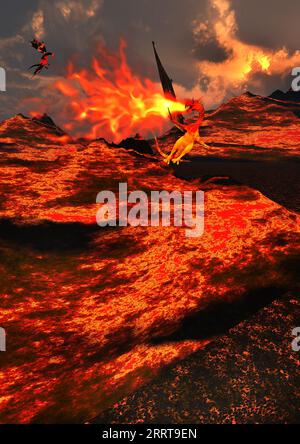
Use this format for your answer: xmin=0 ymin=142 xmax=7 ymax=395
xmin=28 ymin=40 xmax=185 ymax=141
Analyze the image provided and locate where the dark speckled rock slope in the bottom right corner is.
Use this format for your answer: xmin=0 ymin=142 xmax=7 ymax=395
xmin=93 ymin=295 xmax=300 ymax=424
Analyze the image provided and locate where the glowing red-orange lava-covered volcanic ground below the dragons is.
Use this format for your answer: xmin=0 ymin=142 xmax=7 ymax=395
xmin=0 ymin=89 xmax=300 ymax=423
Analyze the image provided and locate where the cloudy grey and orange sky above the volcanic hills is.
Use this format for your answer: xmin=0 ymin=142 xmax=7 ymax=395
xmin=0 ymin=0 xmax=300 ymax=125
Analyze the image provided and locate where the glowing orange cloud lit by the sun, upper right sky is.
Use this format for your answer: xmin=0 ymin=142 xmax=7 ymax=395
xmin=177 ymin=0 xmax=300 ymax=106
